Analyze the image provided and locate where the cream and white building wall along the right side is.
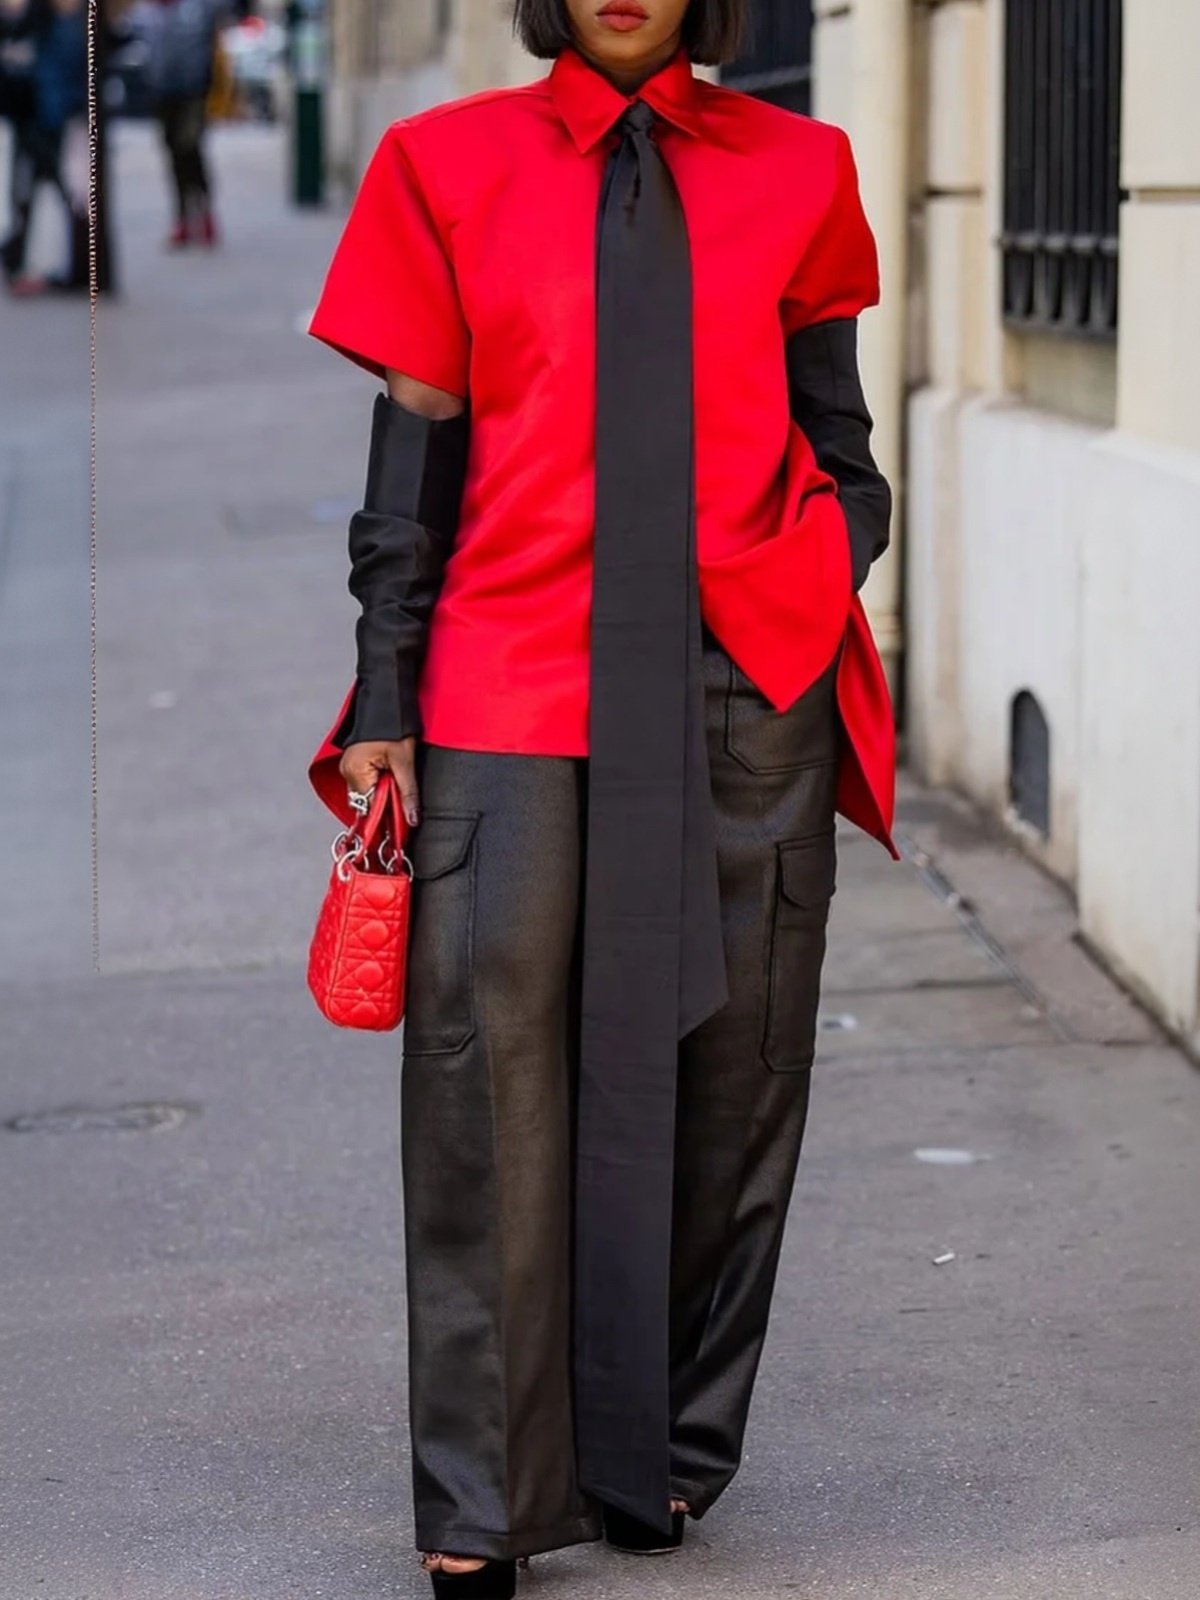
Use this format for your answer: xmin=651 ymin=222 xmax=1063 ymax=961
xmin=906 ymin=0 xmax=1200 ymax=1048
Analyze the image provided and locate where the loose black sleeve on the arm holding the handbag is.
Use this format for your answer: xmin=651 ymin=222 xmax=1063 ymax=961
xmin=339 ymin=394 xmax=470 ymax=747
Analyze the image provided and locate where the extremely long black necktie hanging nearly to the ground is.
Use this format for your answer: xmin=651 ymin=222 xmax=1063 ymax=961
xmin=574 ymin=101 xmax=728 ymax=1530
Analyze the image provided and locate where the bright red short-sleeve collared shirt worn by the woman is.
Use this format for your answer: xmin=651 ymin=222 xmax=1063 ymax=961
xmin=309 ymin=50 xmax=891 ymax=842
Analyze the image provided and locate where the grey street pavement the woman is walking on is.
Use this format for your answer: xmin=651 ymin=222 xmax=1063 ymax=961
xmin=0 ymin=116 xmax=1200 ymax=1600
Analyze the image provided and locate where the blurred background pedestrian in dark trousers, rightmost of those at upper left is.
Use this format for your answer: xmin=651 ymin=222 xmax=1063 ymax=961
xmin=147 ymin=0 xmax=230 ymax=250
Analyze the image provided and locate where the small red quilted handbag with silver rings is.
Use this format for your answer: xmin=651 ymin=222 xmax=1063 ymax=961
xmin=309 ymin=773 xmax=413 ymax=1032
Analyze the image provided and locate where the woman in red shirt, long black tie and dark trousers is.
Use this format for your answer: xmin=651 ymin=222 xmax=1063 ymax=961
xmin=310 ymin=0 xmax=893 ymax=1597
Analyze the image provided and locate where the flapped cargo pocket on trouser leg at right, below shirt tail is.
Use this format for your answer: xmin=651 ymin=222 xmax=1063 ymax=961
xmin=763 ymin=832 xmax=837 ymax=1072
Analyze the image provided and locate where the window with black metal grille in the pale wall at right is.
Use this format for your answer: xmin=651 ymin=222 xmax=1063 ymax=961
xmin=1000 ymin=0 xmax=1122 ymax=338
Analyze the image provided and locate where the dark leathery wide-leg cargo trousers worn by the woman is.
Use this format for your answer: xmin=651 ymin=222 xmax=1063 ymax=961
xmin=402 ymin=635 xmax=842 ymax=1558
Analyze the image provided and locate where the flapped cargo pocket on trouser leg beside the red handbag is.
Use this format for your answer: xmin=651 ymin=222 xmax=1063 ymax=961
xmin=403 ymin=811 xmax=478 ymax=1056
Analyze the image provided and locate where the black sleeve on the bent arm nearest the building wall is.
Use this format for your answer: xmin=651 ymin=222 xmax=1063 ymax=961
xmin=787 ymin=317 xmax=891 ymax=594
